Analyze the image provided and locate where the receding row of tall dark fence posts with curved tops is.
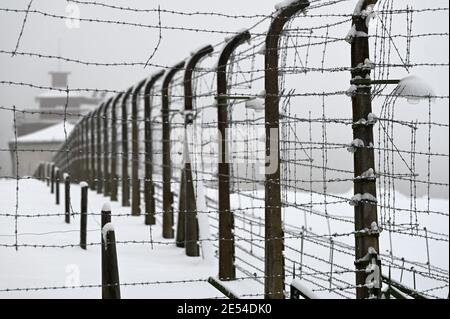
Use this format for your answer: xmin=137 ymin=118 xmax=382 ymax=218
xmin=33 ymin=0 xmax=381 ymax=298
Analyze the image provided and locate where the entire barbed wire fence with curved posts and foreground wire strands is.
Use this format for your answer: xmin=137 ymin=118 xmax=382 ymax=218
xmin=0 ymin=0 xmax=449 ymax=298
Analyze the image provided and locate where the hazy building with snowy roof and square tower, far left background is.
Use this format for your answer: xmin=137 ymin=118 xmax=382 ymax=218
xmin=9 ymin=71 xmax=102 ymax=176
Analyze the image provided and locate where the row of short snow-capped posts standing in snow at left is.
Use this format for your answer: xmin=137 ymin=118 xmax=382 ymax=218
xmin=35 ymin=163 xmax=120 ymax=299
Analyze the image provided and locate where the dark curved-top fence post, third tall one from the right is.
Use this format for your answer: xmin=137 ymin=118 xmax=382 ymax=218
xmin=217 ymin=31 xmax=250 ymax=280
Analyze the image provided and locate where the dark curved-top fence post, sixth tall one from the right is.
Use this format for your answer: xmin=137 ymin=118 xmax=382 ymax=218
xmin=144 ymin=71 xmax=164 ymax=225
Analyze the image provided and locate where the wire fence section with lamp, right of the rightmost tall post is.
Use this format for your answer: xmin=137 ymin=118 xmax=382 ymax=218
xmin=371 ymin=1 xmax=448 ymax=297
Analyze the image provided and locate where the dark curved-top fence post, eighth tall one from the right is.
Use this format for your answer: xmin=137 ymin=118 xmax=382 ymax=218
xmin=122 ymin=88 xmax=133 ymax=207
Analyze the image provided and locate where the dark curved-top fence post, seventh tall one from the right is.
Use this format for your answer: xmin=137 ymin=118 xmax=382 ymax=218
xmin=131 ymin=80 xmax=147 ymax=216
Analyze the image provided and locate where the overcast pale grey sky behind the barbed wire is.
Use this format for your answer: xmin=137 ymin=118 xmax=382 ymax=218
xmin=0 ymin=0 xmax=448 ymax=196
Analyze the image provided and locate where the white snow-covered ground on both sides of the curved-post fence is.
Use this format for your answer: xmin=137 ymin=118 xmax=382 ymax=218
xmin=0 ymin=180 xmax=449 ymax=298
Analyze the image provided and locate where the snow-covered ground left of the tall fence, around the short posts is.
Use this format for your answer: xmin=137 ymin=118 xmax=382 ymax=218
xmin=0 ymin=180 xmax=222 ymax=298
